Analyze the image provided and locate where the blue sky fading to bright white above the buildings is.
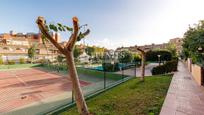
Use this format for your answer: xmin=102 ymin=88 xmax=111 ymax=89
xmin=0 ymin=0 xmax=204 ymax=49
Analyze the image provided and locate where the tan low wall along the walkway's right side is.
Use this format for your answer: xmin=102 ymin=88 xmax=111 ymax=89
xmin=191 ymin=64 xmax=202 ymax=85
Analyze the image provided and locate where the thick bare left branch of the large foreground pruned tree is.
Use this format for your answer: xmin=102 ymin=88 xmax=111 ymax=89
xmin=36 ymin=16 xmax=66 ymax=54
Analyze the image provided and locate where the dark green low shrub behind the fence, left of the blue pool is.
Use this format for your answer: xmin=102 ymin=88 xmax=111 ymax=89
xmin=102 ymin=63 xmax=119 ymax=72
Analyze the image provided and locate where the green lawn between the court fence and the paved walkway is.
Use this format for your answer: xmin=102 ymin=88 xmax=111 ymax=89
xmin=60 ymin=75 xmax=172 ymax=115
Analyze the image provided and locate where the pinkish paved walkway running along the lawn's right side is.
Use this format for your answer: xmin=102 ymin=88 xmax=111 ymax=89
xmin=160 ymin=62 xmax=204 ymax=115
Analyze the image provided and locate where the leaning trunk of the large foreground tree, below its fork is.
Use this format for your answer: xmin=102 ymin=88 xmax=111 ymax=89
xmin=66 ymin=52 xmax=89 ymax=115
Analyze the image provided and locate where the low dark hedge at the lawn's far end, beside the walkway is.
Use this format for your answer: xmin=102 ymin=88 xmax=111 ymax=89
xmin=152 ymin=60 xmax=178 ymax=75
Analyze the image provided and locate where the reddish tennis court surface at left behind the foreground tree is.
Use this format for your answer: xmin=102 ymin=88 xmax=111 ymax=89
xmin=0 ymin=69 xmax=90 ymax=113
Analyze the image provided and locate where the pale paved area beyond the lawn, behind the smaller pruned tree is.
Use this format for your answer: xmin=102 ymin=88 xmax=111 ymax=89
xmin=115 ymin=63 xmax=159 ymax=77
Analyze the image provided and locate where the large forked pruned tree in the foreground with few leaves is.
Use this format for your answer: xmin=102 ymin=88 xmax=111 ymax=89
xmin=36 ymin=17 xmax=90 ymax=115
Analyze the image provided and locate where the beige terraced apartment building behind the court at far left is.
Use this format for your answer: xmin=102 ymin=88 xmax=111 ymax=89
xmin=0 ymin=31 xmax=60 ymax=61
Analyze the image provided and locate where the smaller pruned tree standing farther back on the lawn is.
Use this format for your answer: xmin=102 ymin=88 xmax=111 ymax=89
xmin=136 ymin=47 xmax=145 ymax=81
